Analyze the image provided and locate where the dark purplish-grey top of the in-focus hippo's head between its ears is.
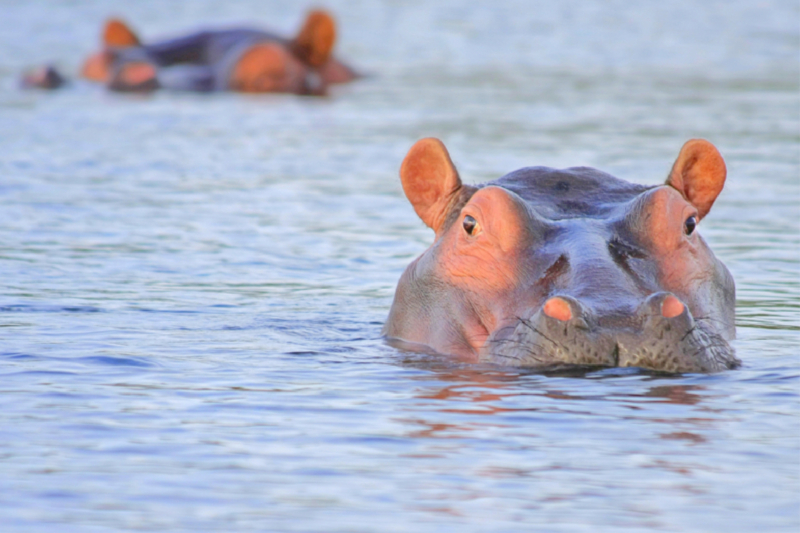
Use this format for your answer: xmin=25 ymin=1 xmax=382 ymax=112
xmin=486 ymin=167 xmax=653 ymax=220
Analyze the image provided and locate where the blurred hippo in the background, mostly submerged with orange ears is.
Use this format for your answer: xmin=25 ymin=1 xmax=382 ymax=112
xmin=23 ymin=10 xmax=358 ymax=95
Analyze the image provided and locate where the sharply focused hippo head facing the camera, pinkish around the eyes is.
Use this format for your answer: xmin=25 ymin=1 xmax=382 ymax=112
xmin=383 ymin=139 xmax=739 ymax=372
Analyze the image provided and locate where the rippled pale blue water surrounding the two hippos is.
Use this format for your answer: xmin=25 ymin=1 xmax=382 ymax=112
xmin=0 ymin=0 xmax=800 ymax=533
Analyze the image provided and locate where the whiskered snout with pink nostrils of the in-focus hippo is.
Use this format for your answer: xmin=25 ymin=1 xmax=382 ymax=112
xmin=484 ymin=292 xmax=739 ymax=372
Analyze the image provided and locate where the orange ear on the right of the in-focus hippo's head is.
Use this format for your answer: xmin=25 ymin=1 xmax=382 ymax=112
xmin=667 ymin=139 xmax=727 ymax=219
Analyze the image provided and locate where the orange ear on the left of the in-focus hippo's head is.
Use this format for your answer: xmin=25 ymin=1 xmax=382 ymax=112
xmin=400 ymin=137 xmax=461 ymax=233
